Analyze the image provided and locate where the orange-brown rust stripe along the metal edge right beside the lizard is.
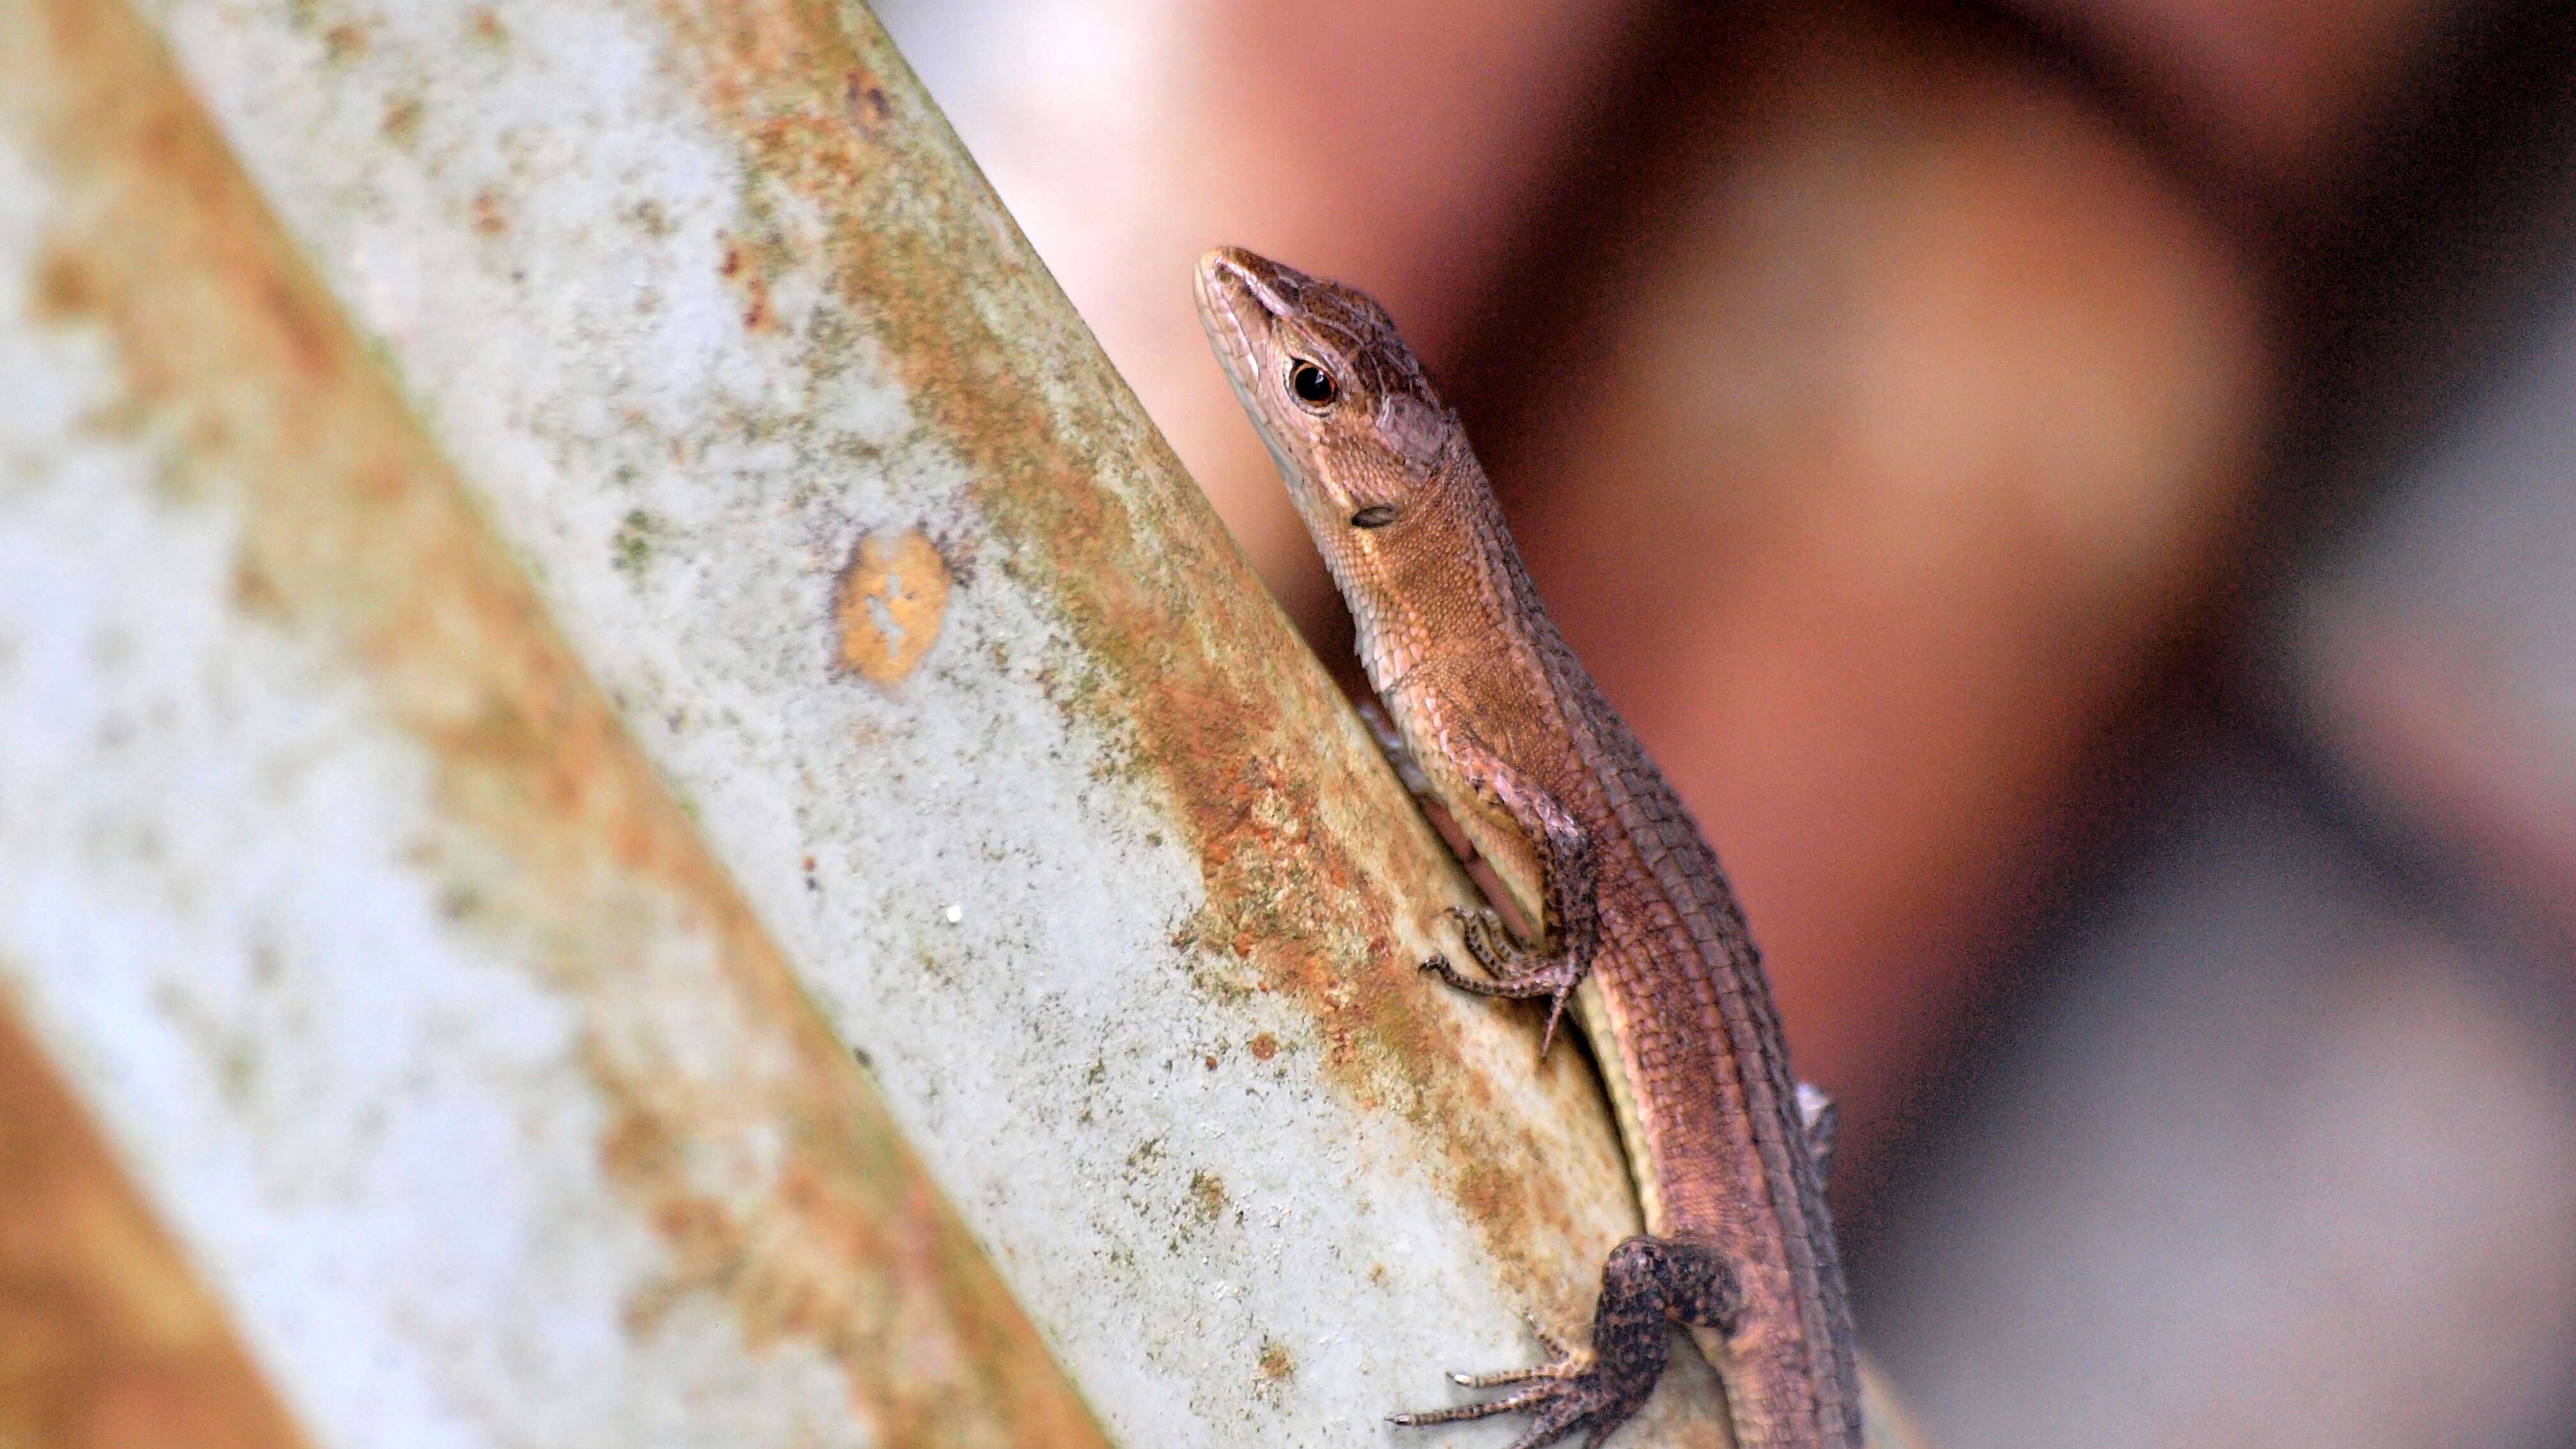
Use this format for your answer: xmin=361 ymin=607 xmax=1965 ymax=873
xmin=644 ymin=0 xmax=1620 ymax=1297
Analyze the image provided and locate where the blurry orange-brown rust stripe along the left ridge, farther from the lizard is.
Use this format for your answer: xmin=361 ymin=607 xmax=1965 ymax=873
xmin=0 ymin=0 xmax=1103 ymax=1449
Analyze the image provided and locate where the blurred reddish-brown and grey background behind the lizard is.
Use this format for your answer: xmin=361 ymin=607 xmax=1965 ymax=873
xmin=876 ymin=0 xmax=2576 ymax=1449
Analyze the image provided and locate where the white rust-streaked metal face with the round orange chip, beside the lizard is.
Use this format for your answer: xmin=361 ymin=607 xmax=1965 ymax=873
xmin=91 ymin=0 xmax=1713 ymax=1444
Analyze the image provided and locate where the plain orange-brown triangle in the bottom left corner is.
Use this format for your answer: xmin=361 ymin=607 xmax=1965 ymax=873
xmin=0 ymin=985 xmax=304 ymax=1449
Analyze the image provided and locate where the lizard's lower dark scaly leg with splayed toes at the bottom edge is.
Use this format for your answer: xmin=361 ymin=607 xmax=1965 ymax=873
xmin=1391 ymin=1235 xmax=1744 ymax=1449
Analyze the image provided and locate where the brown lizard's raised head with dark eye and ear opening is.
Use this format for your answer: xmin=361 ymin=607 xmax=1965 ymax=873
xmin=1198 ymin=247 xmax=1466 ymax=593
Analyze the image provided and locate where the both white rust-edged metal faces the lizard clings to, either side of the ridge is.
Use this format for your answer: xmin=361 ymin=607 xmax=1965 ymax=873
xmin=0 ymin=0 xmax=1937 ymax=1446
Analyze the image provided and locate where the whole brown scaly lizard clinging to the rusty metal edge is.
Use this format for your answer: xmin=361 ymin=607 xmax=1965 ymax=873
xmin=1198 ymin=247 xmax=1862 ymax=1449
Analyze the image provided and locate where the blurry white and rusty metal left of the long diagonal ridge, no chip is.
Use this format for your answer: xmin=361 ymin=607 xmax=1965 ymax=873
xmin=0 ymin=0 xmax=1100 ymax=1446
